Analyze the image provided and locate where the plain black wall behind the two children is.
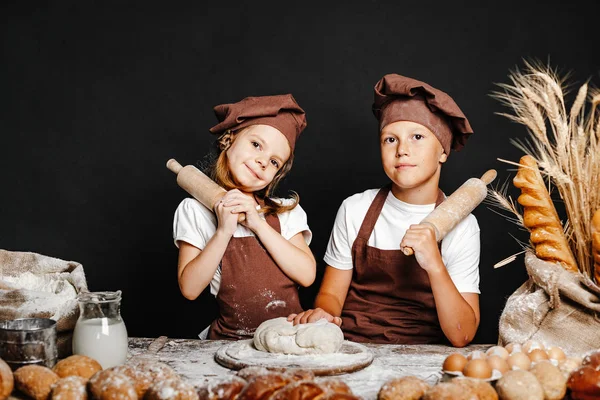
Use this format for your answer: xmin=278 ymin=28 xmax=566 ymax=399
xmin=0 ymin=0 xmax=600 ymax=343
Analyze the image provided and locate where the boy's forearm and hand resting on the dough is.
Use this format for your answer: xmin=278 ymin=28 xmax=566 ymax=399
xmin=288 ymin=265 xmax=352 ymax=326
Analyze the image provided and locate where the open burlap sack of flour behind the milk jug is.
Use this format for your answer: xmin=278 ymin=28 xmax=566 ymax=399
xmin=0 ymin=249 xmax=87 ymax=358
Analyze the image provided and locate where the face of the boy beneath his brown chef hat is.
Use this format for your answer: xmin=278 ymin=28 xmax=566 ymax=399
xmin=379 ymin=121 xmax=447 ymax=196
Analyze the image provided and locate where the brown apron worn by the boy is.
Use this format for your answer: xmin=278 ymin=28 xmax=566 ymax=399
xmin=342 ymin=186 xmax=445 ymax=344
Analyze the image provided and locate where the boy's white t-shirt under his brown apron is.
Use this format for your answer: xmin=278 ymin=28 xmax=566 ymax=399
xmin=324 ymin=189 xmax=480 ymax=293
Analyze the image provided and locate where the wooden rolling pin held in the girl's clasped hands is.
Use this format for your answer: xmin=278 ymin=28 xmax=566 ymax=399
xmin=167 ymin=158 xmax=246 ymax=222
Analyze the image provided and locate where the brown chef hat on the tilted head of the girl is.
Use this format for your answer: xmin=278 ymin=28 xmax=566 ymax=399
xmin=210 ymin=94 xmax=306 ymax=151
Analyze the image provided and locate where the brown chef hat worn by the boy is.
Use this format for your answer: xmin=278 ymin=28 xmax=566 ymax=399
xmin=373 ymin=74 xmax=473 ymax=154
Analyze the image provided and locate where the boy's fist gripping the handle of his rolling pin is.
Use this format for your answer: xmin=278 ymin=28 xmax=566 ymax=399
xmin=400 ymin=224 xmax=444 ymax=272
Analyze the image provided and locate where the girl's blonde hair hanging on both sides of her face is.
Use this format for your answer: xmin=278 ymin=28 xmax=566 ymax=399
xmin=210 ymin=128 xmax=300 ymax=215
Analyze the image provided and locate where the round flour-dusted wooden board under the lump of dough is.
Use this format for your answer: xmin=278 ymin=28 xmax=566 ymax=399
xmin=215 ymin=339 xmax=373 ymax=376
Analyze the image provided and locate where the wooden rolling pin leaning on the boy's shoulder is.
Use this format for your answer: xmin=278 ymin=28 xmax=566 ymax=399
xmin=402 ymin=169 xmax=497 ymax=256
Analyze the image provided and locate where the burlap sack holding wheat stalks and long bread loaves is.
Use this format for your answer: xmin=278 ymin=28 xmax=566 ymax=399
xmin=499 ymin=252 xmax=600 ymax=355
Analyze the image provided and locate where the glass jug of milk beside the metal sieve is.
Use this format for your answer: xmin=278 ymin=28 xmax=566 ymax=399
xmin=73 ymin=290 xmax=127 ymax=369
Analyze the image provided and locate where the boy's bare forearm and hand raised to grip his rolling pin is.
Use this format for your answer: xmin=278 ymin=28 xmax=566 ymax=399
xmin=400 ymin=224 xmax=479 ymax=347
